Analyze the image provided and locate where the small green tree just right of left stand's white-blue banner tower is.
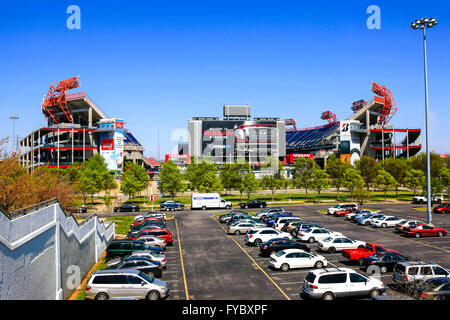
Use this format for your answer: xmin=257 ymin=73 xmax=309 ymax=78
xmin=120 ymin=162 xmax=149 ymax=199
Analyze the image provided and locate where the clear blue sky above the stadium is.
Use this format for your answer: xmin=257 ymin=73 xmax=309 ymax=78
xmin=0 ymin=0 xmax=450 ymax=157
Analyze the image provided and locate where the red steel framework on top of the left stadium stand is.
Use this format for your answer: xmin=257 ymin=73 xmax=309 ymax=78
xmin=42 ymin=76 xmax=80 ymax=124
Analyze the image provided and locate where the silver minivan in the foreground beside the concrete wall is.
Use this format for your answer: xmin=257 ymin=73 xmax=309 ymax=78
xmin=84 ymin=269 xmax=170 ymax=300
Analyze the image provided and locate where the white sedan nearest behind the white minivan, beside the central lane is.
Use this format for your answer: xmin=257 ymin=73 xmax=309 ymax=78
xmin=269 ymin=249 xmax=327 ymax=271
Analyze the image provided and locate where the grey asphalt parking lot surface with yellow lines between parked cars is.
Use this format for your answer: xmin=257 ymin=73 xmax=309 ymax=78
xmin=172 ymin=204 xmax=450 ymax=300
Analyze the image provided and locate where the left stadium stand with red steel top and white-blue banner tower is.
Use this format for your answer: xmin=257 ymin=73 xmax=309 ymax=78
xmin=19 ymin=77 xmax=159 ymax=174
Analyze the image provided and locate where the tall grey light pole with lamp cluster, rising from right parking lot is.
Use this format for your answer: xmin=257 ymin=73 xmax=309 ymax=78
xmin=411 ymin=18 xmax=437 ymax=223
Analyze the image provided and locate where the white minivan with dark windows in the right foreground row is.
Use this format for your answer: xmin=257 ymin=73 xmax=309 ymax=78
xmin=302 ymin=268 xmax=386 ymax=300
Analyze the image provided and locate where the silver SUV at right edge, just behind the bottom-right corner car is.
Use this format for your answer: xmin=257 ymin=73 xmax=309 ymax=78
xmin=392 ymin=261 xmax=450 ymax=285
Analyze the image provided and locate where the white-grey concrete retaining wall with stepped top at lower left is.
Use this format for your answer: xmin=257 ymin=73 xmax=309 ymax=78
xmin=0 ymin=200 xmax=115 ymax=300
